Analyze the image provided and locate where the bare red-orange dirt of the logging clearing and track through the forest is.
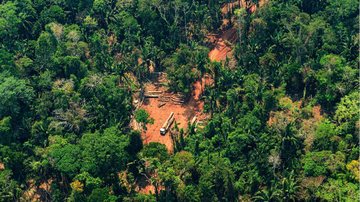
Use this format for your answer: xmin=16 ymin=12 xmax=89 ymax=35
xmin=138 ymin=0 xmax=266 ymax=194
